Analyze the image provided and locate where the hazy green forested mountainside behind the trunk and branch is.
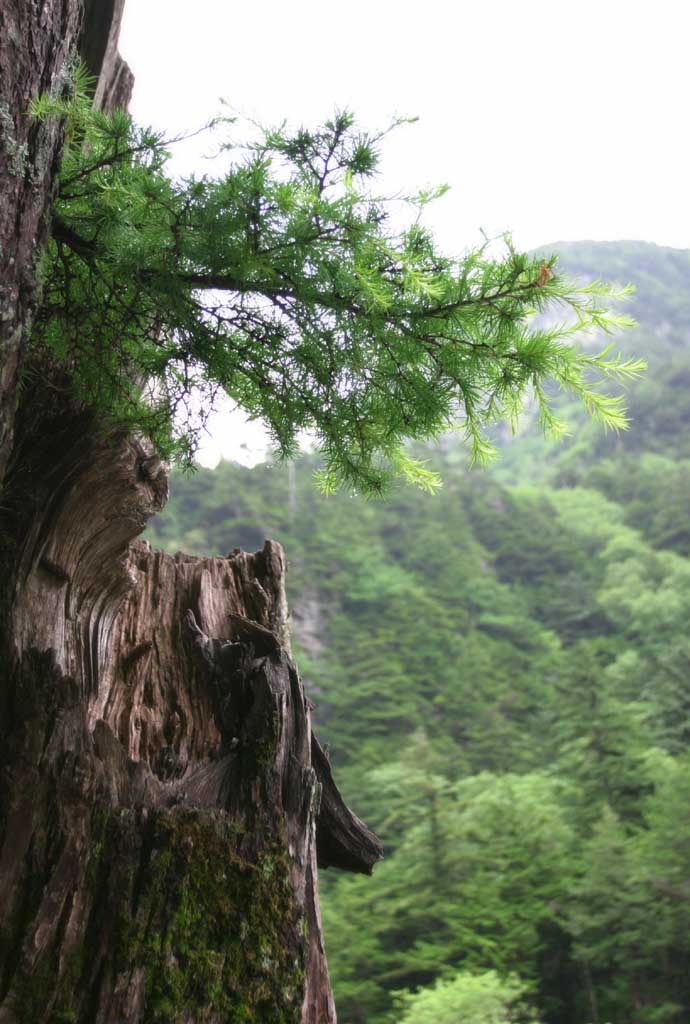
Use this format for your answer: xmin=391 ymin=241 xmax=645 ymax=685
xmin=149 ymin=243 xmax=690 ymax=1024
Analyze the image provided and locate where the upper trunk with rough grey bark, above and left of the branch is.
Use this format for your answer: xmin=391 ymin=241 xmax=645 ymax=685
xmin=0 ymin=0 xmax=132 ymax=481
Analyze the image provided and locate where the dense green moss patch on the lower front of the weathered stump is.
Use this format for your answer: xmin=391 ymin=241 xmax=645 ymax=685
xmin=122 ymin=813 xmax=305 ymax=1024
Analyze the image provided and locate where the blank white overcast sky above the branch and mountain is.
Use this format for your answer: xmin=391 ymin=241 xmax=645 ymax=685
xmin=120 ymin=0 xmax=690 ymax=464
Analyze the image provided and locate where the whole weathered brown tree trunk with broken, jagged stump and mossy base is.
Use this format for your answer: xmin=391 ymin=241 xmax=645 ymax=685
xmin=0 ymin=0 xmax=381 ymax=1024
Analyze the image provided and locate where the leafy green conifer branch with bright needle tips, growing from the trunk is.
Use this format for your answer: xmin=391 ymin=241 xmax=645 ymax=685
xmin=34 ymin=68 xmax=642 ymax=494
